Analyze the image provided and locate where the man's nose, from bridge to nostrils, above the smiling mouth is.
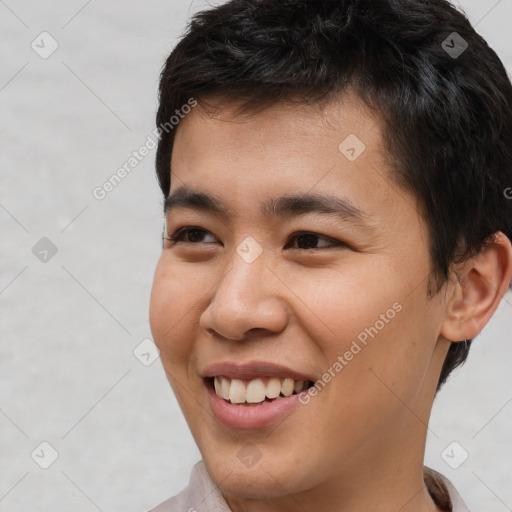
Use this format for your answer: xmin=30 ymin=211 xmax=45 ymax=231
xmin=199 ymin=248 xmax=288 ymax=341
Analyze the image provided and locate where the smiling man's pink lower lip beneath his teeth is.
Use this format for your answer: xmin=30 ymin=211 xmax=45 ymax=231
xmin=206 ymin=383 xmax=306 ymax=428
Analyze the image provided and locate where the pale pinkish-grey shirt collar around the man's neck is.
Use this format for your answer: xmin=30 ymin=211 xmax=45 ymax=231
xmin=149 ymin=461 xmax=469 ymax=512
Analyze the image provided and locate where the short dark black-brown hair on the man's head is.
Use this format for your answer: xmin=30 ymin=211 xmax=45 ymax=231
xmin=156 ymin=0 xmax=512 ymax=390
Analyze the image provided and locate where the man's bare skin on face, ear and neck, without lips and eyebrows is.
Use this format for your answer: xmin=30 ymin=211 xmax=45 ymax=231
xmin=150 ymin=93 xmax=512 ymax=512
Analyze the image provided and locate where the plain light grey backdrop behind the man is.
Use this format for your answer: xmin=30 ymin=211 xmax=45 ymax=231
xmin=0 ymin=0 xmax=512 ymax=512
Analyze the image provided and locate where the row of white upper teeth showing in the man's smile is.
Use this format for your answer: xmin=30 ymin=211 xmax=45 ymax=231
xmin=213 ymin=377 xmax=305 ymax=404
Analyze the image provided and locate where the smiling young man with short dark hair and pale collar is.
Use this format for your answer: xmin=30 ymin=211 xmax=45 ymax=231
xmin=145 ymin=0 xmax=512 ymax=512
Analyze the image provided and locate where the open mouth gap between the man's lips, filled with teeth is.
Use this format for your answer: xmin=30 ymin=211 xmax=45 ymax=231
xmin=205 ymin=375 xmax=313 ymax=407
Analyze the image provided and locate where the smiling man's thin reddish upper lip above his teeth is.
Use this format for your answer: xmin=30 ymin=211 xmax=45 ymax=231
xmin=202 ymin=361 xmax=315 ymax=381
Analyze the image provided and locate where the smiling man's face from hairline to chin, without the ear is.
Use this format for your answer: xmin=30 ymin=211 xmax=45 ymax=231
xmin=150 ymin=94 xmax=447 ymax=499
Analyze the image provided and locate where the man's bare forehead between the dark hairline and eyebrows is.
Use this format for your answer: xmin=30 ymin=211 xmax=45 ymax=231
xmin=171 ymin=94 xmax=424 ymax=234
